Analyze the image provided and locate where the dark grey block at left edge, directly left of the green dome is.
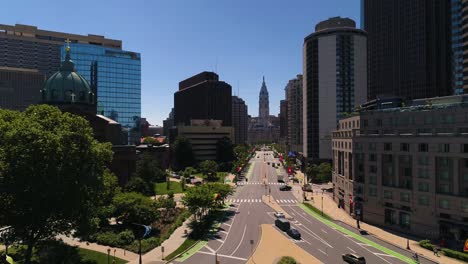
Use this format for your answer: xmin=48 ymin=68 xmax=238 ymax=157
xmin=0 ymin=67 xmax=45 ymax=111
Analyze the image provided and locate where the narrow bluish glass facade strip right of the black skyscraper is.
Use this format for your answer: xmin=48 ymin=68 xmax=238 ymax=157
xmin=450 ymin=0 xmax=463 ymax=94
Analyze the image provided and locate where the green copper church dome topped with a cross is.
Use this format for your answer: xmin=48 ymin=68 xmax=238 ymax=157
xmin=41 ymin=43 xmax=95 ymax=104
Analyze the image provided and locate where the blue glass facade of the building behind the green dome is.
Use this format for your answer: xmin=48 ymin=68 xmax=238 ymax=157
xmin=61 ymin=43 xmax=141 ymax=144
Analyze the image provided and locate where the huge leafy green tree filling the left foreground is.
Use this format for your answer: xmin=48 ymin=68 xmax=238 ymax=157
xmin=0 ymin=105 xmax=112 ymax=264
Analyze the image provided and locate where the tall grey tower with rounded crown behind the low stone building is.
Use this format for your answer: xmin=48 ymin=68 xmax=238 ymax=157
xmin=303 ymin=17 xmax=367 ymax=160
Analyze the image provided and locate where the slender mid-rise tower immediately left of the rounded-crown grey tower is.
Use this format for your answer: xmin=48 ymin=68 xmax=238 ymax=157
xmin=285 ymin=74 xmax=303 ymax=152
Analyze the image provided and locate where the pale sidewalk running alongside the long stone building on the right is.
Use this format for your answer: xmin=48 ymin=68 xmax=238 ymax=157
xmin=307 ymin=193 xmax=463 ymax=264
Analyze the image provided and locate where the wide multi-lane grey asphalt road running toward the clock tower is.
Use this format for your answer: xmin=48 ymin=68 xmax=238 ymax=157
xmin=175 ymin=152 xmax=432 ymax=264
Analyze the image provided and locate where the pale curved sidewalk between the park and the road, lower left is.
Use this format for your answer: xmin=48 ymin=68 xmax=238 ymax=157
xmin=128 ymin=217 xmax=191 ymax=264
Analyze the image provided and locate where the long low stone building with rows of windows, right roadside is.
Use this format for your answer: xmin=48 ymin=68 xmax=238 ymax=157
xmin=332 ymin=95 xmax=468 ymax=239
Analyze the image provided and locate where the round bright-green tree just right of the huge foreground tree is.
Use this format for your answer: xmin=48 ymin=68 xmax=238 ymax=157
xmin=113 ymin=192 xmax=158 ymax=225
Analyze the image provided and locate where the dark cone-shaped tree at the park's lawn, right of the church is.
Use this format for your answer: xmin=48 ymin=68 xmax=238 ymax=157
xmin=135 ymin=153 xmax=166 ymax=184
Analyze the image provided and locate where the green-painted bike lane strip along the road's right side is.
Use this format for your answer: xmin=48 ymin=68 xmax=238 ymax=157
xmin=299 ymin=204 xmax=415 ymax=263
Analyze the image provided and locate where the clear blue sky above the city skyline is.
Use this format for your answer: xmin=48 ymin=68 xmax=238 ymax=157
xmin=4 ymin=0 xmax=360 ymax=125
